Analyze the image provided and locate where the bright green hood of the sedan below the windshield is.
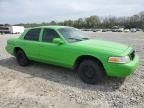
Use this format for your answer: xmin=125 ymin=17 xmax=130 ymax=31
xmin=72 ymin=39 xmax=129 ymax=54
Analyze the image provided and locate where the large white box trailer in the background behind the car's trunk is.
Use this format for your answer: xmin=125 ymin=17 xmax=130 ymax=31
xmin=9 ymin=26 xmax=24 ymax=34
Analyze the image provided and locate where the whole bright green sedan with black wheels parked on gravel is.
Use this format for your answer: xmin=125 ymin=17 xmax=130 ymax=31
xmin=6 ymin=26 xmax=139 ymax=84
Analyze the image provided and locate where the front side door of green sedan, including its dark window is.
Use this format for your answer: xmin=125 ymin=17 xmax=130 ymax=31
xmin=40 ymin=28 xmax=69 ymax=65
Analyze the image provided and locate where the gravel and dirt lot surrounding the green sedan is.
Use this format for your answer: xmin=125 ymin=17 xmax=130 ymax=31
xmin=0 ymin=32 xmax=144 ymax=108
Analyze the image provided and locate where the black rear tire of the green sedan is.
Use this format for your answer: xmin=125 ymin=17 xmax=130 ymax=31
xmin=16 ymin=50 xmax=30 ymax=66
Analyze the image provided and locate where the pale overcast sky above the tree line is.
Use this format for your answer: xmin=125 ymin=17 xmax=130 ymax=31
xmin=0 ymin=0 xmax=144 ymax=24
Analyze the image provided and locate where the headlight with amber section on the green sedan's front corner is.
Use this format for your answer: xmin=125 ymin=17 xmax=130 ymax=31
xmin=108 ymin=56 xmax=130 ymax=63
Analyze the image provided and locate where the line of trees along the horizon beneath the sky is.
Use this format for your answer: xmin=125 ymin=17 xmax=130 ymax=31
xmin=16 ymin=12 xmax=144 ymax=29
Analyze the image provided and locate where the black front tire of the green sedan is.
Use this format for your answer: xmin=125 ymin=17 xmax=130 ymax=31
xmin=78 ymin=60 xmax=104 ymax=84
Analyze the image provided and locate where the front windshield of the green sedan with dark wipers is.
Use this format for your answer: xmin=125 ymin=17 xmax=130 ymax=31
xmin=58 ymin=28 xmax=88 ymax=42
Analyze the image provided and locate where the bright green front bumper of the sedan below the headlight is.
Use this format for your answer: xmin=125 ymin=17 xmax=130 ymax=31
xmin=104 ymin=55 xmax=139 ymax=77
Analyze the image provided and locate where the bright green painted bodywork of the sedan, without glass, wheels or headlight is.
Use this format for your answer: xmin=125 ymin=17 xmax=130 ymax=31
xmin=6 ymin=26 xmax=139 ymax=77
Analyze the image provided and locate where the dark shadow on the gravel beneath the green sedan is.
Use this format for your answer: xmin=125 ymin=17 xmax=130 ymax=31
xmin=0 ymin=57 xmax=125 ymax=92
